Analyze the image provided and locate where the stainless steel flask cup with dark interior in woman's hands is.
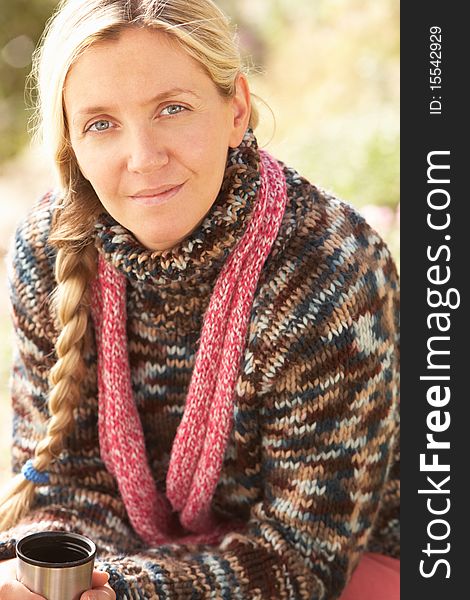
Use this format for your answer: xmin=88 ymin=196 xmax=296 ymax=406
xmin=16 ymin=531 xmax=96 ymax=600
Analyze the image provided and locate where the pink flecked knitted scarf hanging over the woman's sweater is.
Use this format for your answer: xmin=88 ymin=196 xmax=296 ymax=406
xmin=92 ymin=151 xmax=287 ymax=545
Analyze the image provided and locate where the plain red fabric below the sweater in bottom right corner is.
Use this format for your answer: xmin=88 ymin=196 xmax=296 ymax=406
xmin=339 ymin=553 xmax=400 ymax=600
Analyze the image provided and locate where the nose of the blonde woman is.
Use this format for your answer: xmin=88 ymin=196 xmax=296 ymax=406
xmin=127 ymin=129 xmax=168 ymax=174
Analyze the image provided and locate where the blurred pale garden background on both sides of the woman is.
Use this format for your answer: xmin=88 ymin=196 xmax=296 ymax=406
xmin=0 ymin=0 xmax=400 ymax=484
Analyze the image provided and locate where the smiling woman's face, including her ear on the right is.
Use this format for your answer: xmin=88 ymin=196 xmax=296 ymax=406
xmin=64 ymin=29 xmax=250 ymax=250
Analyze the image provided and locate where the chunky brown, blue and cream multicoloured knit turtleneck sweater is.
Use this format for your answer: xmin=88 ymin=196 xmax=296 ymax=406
xmin=0 ymin=134 xmax=399 ymax=600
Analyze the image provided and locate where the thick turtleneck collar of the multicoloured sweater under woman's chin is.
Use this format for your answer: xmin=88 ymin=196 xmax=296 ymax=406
xmin=96 ymin=129 xmax=261 ymax=285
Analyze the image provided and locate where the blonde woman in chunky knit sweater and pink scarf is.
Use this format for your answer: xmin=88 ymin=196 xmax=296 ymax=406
xmin=0 ymin=0 xmax=399 ymax=600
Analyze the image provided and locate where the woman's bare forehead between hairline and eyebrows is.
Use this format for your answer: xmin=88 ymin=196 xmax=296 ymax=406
xmin=64 ymin=28 xmax=215 ymax=107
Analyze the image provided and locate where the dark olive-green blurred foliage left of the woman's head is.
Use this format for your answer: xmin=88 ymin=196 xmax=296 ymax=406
xmin=0 ymin=0 xmax=56 ymax=163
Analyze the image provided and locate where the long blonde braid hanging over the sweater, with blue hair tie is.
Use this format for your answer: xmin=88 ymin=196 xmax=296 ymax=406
xmin=0 ymin=233 xmax=96 ymax=530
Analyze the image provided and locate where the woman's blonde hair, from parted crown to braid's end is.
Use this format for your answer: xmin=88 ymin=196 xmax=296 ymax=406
xmin=0 ymin=0 xmax=258 ymax=529
